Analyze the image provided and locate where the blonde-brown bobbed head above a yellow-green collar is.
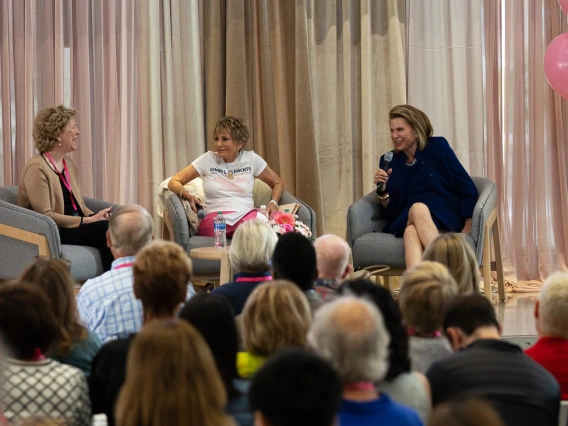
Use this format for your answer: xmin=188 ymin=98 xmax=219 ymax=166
xmin=242 ymin=280 xmax=312 ymax=356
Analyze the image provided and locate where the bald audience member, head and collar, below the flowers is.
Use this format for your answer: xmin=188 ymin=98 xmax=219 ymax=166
xmin=314 ymin=234 xmax=353 ymax=299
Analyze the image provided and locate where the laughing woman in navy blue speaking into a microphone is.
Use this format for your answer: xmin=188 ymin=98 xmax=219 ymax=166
xmin=373 ymin=105 xmax=478 ymax=268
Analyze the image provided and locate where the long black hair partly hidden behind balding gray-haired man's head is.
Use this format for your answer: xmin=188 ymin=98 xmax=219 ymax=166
xmin=339 ymin=279 xmax=411 ymax=380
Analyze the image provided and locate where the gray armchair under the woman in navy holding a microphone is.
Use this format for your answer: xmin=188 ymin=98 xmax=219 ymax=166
xmin=347 ymin=177 xmax=505 ymax=300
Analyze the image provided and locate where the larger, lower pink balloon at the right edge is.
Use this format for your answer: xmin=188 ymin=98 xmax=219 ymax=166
xmin=544 ymin=33 xmax=568 ymax=99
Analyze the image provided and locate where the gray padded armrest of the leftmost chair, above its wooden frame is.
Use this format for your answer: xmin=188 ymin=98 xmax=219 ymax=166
xmin=0 ymin=201 xmax=61 ymax=258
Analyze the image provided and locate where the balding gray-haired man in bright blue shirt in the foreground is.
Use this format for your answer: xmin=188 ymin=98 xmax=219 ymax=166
xmin=308 ymin=296 xmax=422 ymax=426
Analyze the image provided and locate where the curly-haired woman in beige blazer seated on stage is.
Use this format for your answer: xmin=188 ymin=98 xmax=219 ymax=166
xmin=18 ymin=105 xmax=113 ymax=271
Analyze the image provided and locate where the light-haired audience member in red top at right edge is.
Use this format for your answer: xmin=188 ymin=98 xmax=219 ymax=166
xmin=525 ymin=272 xmax=568 ymax=400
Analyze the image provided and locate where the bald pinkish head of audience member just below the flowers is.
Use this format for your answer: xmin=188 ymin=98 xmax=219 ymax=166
xmin=314 ymin=234 xmax=351 ymax=281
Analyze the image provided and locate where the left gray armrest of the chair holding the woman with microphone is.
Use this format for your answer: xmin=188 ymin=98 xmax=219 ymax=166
xmin=347 ymin=191 xmax=387 ymax=247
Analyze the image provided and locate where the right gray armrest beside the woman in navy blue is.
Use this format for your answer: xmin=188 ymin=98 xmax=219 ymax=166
xmin=470 ymin=176 xmax=497 ymax=264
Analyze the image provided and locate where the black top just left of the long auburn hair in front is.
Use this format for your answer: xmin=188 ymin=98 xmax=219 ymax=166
xmin=89 ymin=334 xmax=135 ymax=426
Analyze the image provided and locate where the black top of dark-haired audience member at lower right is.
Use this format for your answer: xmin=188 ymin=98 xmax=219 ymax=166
xmin=426 ymin=339 xmax=560 ymax=426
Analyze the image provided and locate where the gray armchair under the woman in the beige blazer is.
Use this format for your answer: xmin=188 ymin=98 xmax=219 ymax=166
xmin=0 ymin=186 xmax=113 ymax=281
